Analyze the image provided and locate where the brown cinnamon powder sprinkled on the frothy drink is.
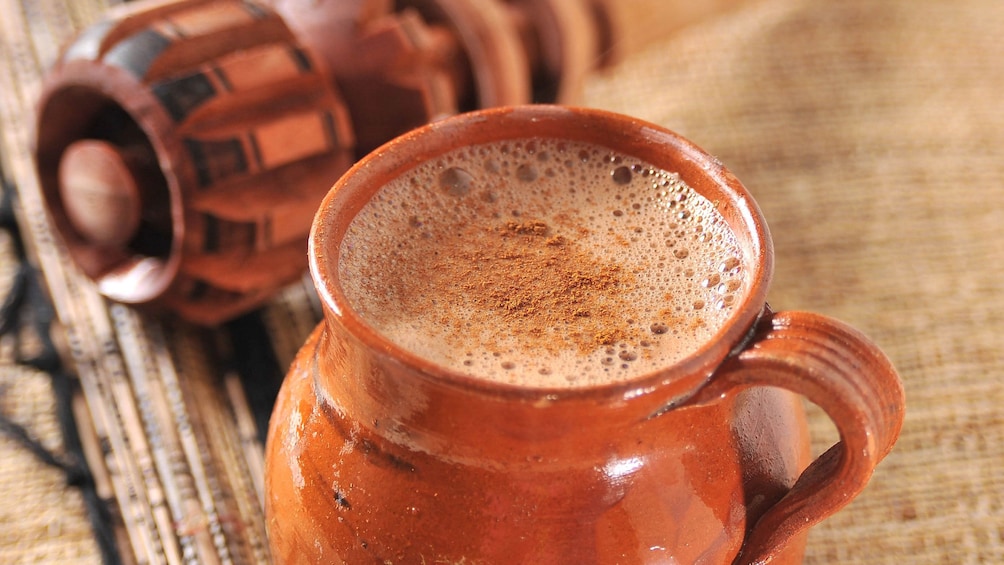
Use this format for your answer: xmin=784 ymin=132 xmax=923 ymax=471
xmin=409 ymin=220 xmax=642 ymax=352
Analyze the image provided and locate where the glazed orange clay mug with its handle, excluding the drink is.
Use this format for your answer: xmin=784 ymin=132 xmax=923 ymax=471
xmin=266 ymin=106 xmax=905 ymax=563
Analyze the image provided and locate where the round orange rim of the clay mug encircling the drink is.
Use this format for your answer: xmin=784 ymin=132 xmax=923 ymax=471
xmin=307 ymin=104 xmax=773 ymax=400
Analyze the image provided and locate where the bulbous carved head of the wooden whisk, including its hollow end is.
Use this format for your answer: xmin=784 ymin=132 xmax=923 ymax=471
xmin=35 ymin=0 xmax=354 ymax=324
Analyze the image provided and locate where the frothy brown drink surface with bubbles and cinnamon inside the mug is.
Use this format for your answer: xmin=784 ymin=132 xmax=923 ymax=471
xmin=338 ymin=138 xmax=749 ymax=387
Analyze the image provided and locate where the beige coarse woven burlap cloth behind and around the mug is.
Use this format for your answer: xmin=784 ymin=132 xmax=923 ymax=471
xmin=0 ymin=0 xmax=1004 ymax=564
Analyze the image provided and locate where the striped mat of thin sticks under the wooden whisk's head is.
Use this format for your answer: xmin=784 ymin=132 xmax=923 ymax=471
xmin=0 ymin=0 xmax=314 ymax=563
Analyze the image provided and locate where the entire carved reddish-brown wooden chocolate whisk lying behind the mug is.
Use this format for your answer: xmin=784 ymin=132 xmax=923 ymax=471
xmin=35 ymin=0 xmax=750 ymax=324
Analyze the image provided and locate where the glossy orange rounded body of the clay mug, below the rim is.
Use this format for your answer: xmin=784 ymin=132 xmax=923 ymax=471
xmin=266 ymin=324 xmax=808 ymax=564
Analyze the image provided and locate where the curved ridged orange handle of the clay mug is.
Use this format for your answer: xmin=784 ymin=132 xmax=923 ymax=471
xmin=687 ymin=309 xmax=906 ymax=565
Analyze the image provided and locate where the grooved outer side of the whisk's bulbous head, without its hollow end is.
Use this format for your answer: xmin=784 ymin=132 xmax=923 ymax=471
xmin=44 ymin=0 xmax=354 ymax=321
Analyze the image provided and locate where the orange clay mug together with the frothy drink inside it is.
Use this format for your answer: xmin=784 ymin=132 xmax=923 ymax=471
xmin=265 ymin=105 xmax=904 ymax=565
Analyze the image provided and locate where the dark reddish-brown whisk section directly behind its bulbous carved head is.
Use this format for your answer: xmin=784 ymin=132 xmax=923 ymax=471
xmin=272 ymin=0 xmax=465 ymax=158
